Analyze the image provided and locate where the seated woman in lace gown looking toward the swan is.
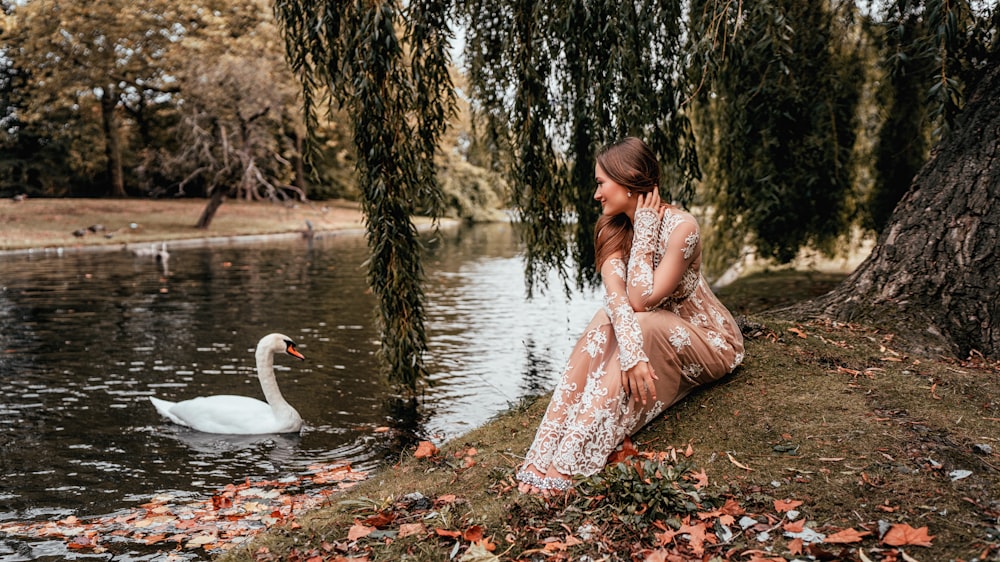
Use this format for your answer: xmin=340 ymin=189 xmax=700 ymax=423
xmin=517 ymin=137 xmax=743 ymax=494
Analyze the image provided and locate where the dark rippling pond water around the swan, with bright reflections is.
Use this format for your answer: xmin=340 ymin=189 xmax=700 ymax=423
xmin=0 ymin=224 xmax=598 ymax=560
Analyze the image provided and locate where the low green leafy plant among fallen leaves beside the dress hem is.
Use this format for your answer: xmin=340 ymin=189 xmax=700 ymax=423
xmin=574 ymin=459 xmax=711 ymax=527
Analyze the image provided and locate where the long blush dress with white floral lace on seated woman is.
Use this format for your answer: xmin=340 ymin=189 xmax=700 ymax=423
xmin=517 ymin=207 xmax=743 ymax=489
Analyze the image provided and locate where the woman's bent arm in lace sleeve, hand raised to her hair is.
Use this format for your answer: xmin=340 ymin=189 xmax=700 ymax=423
xmin=628 ymin=191 xmax=698 ymax=312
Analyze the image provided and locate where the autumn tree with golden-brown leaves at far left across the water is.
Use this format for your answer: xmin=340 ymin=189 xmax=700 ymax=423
xmin=1 ymin=0 xmax=189 ymax=196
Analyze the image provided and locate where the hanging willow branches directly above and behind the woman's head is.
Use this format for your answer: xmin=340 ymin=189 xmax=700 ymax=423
xmin=459 ymin=0 xmax=698 ymax=294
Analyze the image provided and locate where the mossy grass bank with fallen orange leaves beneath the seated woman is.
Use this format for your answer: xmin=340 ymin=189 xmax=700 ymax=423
xmin=222 ymin=272 xmax=1000 ymax=561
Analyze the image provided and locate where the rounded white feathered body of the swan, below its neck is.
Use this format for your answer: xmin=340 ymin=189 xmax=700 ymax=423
xmin=168 ymin=395 xmax=279 ymax=435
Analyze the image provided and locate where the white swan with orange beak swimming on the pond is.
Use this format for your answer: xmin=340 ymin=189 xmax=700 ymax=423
xmin=149 ymin=334 xmax=305 ymax=435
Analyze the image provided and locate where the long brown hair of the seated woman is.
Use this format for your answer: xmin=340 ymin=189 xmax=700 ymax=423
xmin=594 ymin=137 xmax=660 ymax=270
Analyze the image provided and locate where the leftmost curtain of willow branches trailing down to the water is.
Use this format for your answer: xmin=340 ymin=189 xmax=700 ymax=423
xmin=274 ymin=0 xmax=455 ymax=389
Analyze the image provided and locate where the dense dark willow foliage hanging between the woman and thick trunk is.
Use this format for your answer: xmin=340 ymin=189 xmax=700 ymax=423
xmin=696 ymin=0 xmax=863 ymax=271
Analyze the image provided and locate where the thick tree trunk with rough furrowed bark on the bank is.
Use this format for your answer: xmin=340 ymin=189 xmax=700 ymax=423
xmin=787 ymin=65 xmax=1000 ymax=359
